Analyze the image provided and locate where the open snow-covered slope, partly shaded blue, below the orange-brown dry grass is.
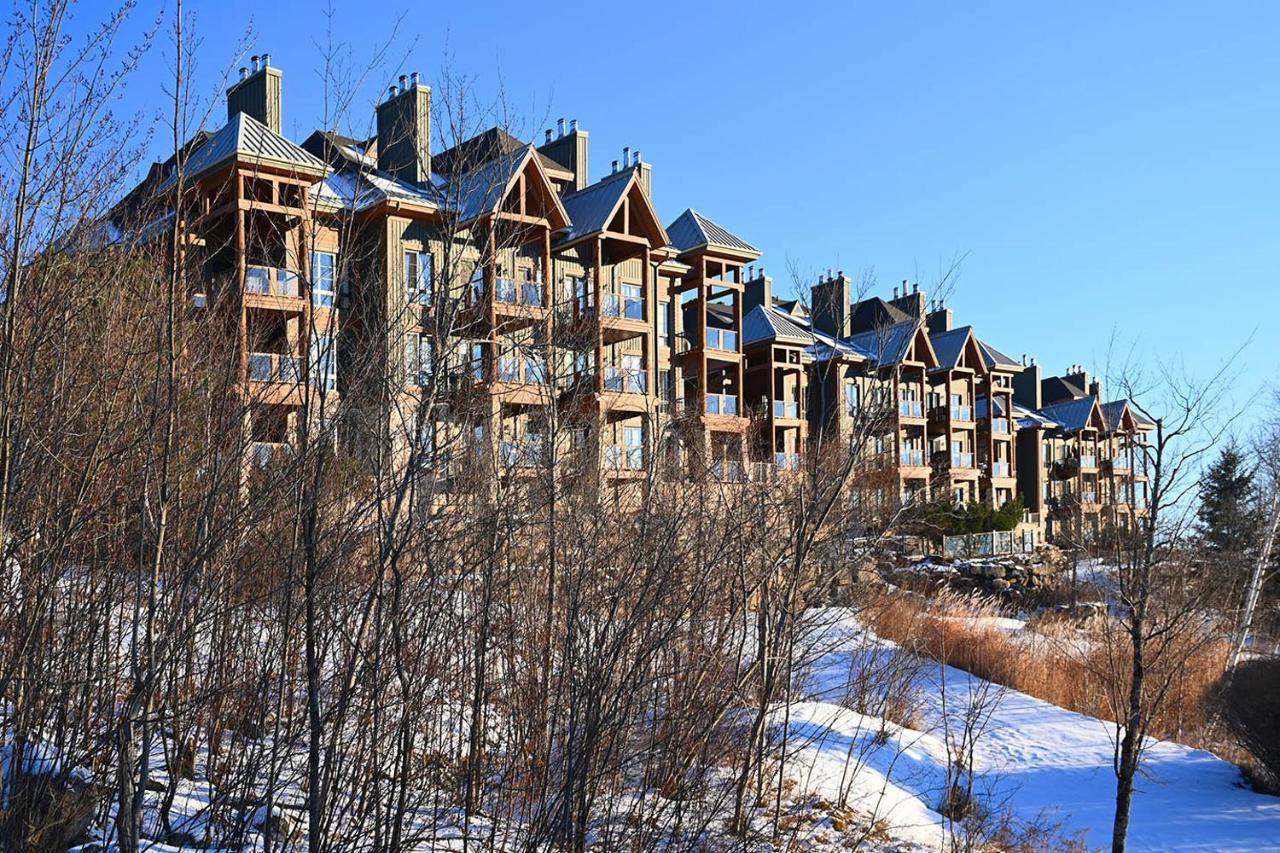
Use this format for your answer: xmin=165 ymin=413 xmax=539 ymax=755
xmin=788 ymin=610 xmax=1280 ymax=852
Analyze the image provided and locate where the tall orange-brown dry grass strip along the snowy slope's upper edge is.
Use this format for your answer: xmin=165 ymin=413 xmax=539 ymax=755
xmin=865 ymin=592 xmax=1226 ymax=752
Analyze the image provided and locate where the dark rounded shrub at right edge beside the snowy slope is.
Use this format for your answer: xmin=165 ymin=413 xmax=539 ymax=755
xmin=1213 ymin=658 xmax=1280 ymax=790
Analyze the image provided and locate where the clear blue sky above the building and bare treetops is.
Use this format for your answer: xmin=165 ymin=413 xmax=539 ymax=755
xmin=81 ymin=0 xmax=1280 ymax=414
